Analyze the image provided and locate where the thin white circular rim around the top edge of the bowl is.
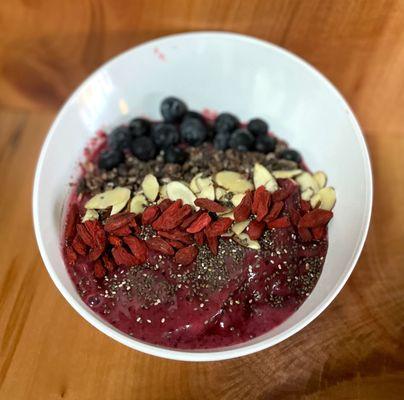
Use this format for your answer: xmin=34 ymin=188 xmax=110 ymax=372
xmin=32 ymin=31 xmax=373 ymax=361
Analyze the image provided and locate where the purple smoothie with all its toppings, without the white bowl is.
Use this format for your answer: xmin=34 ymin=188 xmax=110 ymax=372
xmin=62 ymin=97 xmax=336 ymax=349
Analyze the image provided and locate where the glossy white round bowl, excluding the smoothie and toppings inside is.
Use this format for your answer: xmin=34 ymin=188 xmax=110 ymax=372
xmin=33 ymin=32 xmax=372 ymax=361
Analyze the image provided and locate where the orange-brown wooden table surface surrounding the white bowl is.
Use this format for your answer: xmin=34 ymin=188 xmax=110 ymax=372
xmin=0 ymin=0 xmax=404 ymax=400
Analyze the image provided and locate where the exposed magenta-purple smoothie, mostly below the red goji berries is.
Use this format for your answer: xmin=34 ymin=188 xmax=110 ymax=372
xmin=66 ymin=117 xmax=328 ymax=349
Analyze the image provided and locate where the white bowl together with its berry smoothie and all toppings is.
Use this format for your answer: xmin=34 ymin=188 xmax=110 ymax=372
xmin=33 ymin=33 xmax=372 ymax=361
